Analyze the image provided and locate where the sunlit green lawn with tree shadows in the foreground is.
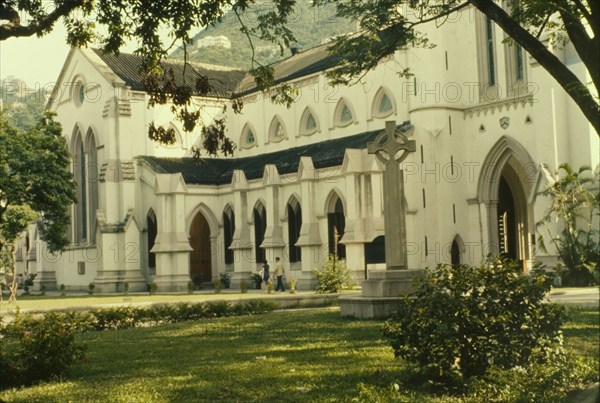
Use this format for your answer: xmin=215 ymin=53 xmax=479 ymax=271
xmin=0 ymin=308 xmax=600 ymax=402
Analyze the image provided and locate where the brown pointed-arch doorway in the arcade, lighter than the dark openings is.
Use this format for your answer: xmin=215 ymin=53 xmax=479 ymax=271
xmin=190 ymin=212 xmax=212 ymax=285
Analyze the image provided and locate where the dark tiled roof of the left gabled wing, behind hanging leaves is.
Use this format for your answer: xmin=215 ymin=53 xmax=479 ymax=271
xmin=94 ymin=49 xmax=246 ymax=98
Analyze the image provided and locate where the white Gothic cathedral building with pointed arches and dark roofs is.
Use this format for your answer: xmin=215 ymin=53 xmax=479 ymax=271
xmin=18 ymin=8 xmax=599 ymax=292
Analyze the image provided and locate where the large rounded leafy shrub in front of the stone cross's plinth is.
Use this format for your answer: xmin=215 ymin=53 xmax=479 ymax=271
xmin=384 ymin=260 xmax=566 ymax=384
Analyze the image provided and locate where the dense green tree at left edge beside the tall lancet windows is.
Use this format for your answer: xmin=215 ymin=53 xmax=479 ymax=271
xmin=0 ymin=114 xmax=77 ymax=252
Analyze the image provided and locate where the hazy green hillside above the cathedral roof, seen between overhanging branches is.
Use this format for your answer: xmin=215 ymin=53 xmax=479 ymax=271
xmin=171 ymin=1 xmax=356 ymax=70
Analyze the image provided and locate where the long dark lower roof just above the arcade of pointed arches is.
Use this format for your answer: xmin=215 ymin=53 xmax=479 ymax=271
xmin=141 ymin=122 xmax=410 ymax=185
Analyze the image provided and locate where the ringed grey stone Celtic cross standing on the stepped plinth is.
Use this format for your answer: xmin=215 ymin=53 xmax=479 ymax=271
xmin=367 ymin=121 xmax=416 ymax=270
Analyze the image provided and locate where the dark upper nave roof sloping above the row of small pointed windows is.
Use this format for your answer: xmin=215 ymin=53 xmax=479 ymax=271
xmin=236 ymin=43 xmax=339 ymax=95
